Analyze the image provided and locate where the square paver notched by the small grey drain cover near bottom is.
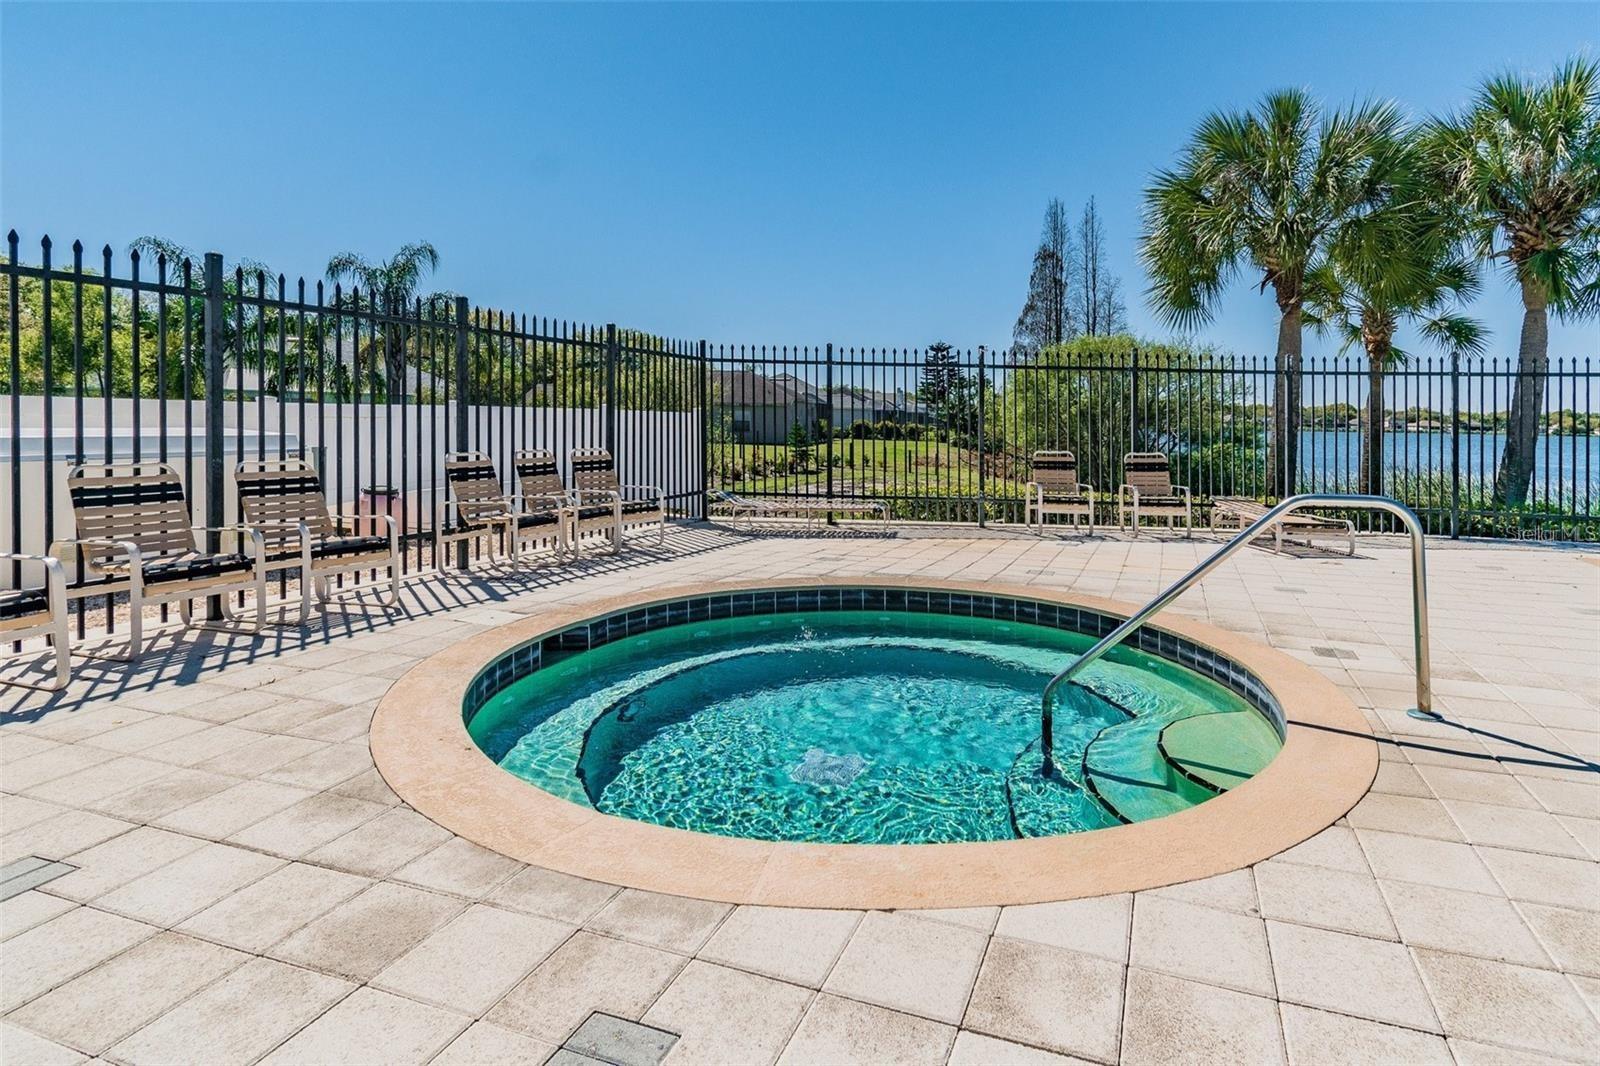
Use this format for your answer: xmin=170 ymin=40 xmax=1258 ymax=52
xmin=485 ymin=932 xmax=685 ymax=1044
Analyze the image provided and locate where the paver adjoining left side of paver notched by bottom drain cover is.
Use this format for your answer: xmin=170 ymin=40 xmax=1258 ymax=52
xmin=373 ymin=904 xmax=574 ymax=1016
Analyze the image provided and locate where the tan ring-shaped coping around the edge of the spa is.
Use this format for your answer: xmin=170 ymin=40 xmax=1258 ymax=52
xmin=371 ymin=578 xmax=1378 ymax=909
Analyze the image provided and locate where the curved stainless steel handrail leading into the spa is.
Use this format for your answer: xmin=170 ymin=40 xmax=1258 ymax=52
xmin=1038 ymin=493 xmax=1434 ymax=775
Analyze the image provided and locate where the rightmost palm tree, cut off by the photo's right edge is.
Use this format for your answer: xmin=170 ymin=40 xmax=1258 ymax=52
xmin=1429 ymin=59 xmax=1600 ymax=504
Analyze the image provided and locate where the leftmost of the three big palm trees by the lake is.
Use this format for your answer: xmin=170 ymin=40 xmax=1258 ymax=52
xmin=1139 ymin=90 xmax=1402 ymax=496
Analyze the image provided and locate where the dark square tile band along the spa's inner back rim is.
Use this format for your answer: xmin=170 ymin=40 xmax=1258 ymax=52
xmin=461 ymin=584 xmax=1285 ymax=738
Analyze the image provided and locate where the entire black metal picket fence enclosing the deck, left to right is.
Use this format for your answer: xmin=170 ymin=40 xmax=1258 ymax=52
xmin=0 ymin=232 xmax=1600 ymax=614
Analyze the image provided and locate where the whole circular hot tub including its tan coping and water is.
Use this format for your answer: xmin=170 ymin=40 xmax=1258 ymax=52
xmin=373 ymin=581 xmax=1376 ymax=906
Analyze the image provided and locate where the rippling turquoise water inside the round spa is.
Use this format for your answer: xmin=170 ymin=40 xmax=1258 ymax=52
xmin=469 ymin=611 xmax=1273 ymax=844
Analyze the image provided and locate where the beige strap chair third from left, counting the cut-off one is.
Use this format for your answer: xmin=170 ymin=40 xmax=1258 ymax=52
xmin=234 ymin=459 xmax=400 ymax=624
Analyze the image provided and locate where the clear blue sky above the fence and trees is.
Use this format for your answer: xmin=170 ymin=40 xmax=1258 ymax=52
xmin=0 ymin=2 xmax=1600 ymax=355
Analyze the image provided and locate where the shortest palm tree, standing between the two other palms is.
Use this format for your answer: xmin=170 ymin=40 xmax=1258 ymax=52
xmin=1306 ymin=145 xmax=1485 ymax=493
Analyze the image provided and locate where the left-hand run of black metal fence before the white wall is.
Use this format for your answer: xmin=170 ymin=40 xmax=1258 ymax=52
xmin=0 ymin=232 xmax=706 ymax=627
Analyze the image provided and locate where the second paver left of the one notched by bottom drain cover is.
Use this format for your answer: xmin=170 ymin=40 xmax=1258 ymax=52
xmin=272 ymin=882 xmax=464 ymax=981
